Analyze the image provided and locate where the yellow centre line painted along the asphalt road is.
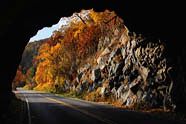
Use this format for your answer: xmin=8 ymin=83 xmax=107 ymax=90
xmin=39 ymin=94 xmax=117 ymax=124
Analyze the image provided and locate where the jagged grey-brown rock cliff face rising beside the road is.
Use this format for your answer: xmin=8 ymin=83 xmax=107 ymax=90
xmin=60 ymin=9 xmax=179 ymax=110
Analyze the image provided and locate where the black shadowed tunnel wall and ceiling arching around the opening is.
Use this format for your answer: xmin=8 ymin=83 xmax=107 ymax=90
xmin=0 ymin=0 xmax=184 ymax=112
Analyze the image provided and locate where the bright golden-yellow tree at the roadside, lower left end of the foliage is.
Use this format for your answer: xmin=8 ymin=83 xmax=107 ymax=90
xmin=35 ymin=39 xmax=69 ymax=91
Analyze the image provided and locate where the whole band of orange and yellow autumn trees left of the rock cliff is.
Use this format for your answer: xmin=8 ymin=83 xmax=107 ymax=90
xmin=32 ymin=9 xmax=126 ymax=93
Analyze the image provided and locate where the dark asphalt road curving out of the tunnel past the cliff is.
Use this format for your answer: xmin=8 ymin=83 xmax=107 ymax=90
xmin=15 ymin=88 xmax=184 ymax=124
